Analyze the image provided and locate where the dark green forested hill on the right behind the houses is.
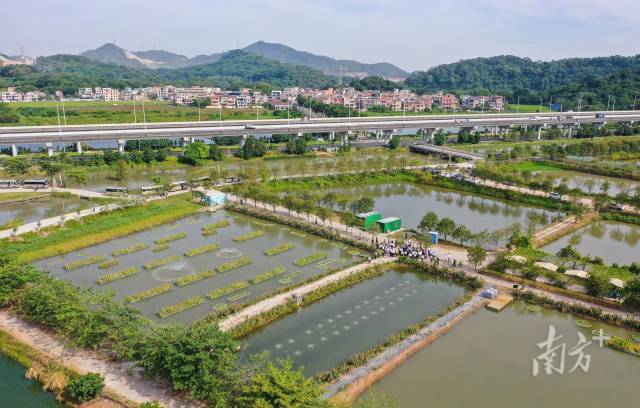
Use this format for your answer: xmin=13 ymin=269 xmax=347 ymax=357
xmin=405 ymin=55 xmax=640 ymax=95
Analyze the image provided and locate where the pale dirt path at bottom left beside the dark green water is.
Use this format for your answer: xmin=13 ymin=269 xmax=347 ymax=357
xmin=0 ymin=309 xmax=198 ymax=408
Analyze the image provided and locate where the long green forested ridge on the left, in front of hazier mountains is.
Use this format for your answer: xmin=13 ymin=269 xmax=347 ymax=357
xmin=0 ymin=50 xmax=337 ymax=94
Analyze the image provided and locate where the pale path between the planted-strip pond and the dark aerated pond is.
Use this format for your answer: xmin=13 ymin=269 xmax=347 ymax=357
xmin=219 ymin=257 xmax=394 ymax=331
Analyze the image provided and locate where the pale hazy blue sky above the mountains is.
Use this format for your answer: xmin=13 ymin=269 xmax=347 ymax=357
xmin=0 ymin=0 xmax=640 ymax=70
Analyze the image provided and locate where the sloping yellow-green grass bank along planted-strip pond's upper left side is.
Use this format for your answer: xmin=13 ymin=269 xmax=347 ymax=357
xmin=2 ymin=195 xmax=201 ymax=261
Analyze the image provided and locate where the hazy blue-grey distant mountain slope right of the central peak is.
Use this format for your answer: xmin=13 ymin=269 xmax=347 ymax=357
xmin=243 ymin=41 xmax=409 ymax=78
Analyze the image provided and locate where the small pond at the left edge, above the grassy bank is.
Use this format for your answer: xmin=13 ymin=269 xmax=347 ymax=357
xmin=0 ymin=197 xmax=96 ymax=225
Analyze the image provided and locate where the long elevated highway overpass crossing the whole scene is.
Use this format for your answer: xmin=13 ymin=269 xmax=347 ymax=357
xmin=0 ymin=111 xmax=640 ymax=153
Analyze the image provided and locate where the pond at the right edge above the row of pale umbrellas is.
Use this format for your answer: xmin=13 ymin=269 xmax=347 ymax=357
xmin=541 ymin=221 xmax=640 ymax=265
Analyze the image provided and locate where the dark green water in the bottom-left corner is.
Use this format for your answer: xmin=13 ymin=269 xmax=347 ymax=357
xmin=0 ymin=353 xmax=64 ymax=408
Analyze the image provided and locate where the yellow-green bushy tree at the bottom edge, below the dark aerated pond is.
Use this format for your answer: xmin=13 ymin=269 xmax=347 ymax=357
xmin=241 ymin=359 xmax=331 ymax=408
